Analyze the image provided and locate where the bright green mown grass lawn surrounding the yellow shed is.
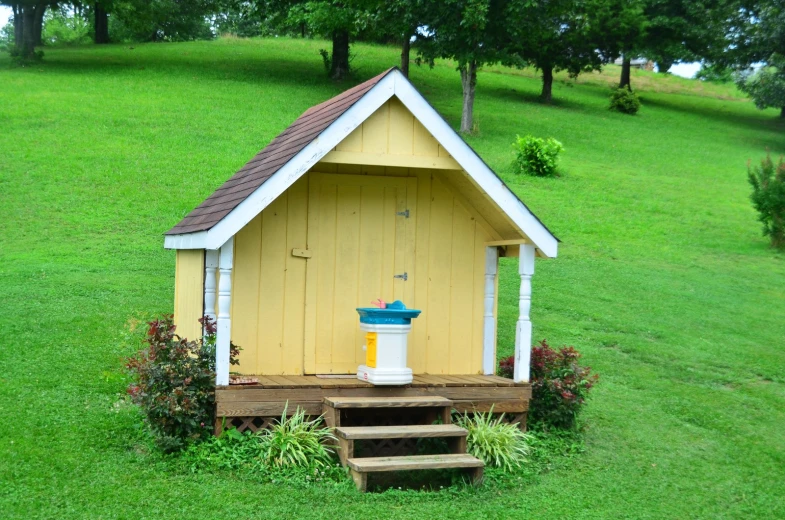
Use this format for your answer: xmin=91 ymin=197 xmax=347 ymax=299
xmin=0 ymin=39 xmax=785 ymax=520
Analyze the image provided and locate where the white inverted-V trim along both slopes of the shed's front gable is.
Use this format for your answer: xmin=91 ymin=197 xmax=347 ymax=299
xmin=164 ymin=69 xmax=558 ymax=258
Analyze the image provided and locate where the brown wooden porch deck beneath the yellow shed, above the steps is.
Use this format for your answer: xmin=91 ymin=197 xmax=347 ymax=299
xmin=216 ymin=374 xmax=531 ymax=426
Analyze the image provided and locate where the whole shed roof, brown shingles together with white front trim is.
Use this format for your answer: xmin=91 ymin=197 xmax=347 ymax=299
xmin=165 ymin=67 xmax=557 ymax=256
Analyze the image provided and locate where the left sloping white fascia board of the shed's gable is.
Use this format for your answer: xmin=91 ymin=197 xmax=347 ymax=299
xmin=164 ymin=71 xmax=397 ymax=249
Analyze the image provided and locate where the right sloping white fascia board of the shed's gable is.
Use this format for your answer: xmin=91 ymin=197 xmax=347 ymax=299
xmin=392 ymin=70 xmax=558 ymax=258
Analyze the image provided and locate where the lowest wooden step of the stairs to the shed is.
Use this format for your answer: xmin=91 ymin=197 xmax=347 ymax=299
xmin=348 ymin=453 xmax=485 ymax=491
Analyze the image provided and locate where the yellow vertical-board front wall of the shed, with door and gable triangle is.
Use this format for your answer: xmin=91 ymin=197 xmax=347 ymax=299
xmin=232 ymin=99 xmax=516 ymax=375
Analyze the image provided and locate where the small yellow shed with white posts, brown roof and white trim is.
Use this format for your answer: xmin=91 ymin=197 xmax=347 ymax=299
xmin=165 ymin=68 xmax=558 ymax=426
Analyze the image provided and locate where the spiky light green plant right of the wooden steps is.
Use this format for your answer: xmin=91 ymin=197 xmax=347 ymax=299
xmin=455 ymin=410 xmax=529 ymax=471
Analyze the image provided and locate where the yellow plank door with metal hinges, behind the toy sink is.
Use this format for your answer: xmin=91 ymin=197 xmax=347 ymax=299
xmin=304 ymin=173 xmax=417 ymax=374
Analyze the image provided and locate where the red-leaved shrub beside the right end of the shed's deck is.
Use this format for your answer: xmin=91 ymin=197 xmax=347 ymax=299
xmin=499 ymin=340 xmax=599 ymax=429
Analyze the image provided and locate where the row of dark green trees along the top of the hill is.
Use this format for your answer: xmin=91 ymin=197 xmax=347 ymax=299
xmin=0 ymin=0 xmax=785 ymax=121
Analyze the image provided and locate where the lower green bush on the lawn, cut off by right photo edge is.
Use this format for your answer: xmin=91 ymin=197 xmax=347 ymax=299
xmin=747 ymin=154 xmax=785 ymax=249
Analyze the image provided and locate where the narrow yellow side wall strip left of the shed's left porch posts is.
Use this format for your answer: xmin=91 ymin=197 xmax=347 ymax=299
xmin=174 ymin=249 xmax=204 ymax=340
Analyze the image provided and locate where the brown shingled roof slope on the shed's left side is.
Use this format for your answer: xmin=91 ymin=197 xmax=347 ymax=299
xmin=166 ymin=69 xmax=393 ymax=235
